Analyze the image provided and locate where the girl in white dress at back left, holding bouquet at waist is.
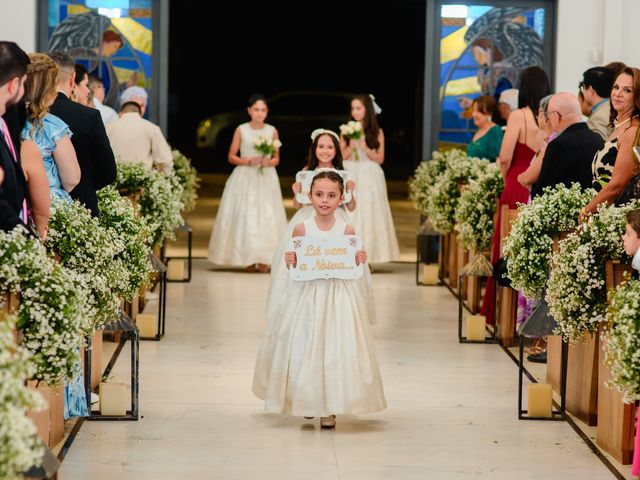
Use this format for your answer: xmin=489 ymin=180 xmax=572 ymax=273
xmin=209 ymin=94 xmax=287 ymax=272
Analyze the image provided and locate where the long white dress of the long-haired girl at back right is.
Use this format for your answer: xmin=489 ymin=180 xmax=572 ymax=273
xmin=343 ymin=148 xmax=400 ymax=263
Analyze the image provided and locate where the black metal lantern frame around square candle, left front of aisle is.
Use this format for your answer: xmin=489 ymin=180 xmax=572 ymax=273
xmin=85 ymin=311 xmax=140 ymax=420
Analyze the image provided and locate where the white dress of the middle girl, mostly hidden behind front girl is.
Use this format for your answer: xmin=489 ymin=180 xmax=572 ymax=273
xmin=267 ymin=205 xmax=376 ymax=325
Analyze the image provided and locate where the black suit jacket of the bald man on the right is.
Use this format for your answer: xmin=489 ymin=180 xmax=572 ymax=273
xmin=531 ymin=122 xmax=604 ymax=198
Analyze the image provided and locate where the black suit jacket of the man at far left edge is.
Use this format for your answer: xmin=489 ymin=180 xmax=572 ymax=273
xmin=0 ymin=125 xmax=27 ymax=231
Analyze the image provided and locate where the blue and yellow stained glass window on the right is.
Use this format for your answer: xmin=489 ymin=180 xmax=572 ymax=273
xmin=439 ymin=4 xmax=545 ymax=148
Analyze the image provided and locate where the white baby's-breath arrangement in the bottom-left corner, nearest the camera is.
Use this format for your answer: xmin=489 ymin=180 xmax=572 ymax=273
xmin=0 ymin=316 xmax=46 ymax=480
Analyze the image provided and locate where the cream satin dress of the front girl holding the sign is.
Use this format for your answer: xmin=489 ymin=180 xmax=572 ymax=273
xmin=252 ymin=217 xmax=387 ymax=417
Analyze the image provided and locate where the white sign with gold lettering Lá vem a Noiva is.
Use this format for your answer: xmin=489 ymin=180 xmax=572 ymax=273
xmin=287 ymin=235 xmax=364 ymax=282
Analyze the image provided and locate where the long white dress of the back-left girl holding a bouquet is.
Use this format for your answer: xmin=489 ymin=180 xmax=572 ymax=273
xmin=208 ymin=123 xmax=287 ymax=266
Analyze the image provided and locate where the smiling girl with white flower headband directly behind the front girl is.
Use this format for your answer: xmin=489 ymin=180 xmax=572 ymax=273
xmin=267 ymin=128 xmax=375 ymax=323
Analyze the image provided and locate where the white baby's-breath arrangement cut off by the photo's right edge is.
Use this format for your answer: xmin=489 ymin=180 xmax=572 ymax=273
xmin=604 ymin=280 xmax=640 ymax=402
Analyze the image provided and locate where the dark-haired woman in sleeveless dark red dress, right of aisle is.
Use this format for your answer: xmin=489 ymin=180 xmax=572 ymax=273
xmin=481 ymin=67 xmax=551 ymax=325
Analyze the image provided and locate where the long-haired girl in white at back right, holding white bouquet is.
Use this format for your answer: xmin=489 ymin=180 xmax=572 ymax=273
xmin=340 ymin=95 xmax=400 ymax=263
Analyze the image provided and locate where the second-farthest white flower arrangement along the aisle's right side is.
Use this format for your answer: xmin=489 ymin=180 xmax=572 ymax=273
xmin=426 ymin=151 xmax=489 ymax=234
